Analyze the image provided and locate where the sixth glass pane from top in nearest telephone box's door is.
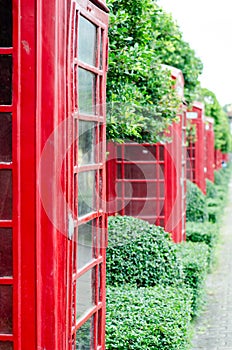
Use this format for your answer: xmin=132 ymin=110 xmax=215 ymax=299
xmin=77 ymin=268 xmax=96 ymax=319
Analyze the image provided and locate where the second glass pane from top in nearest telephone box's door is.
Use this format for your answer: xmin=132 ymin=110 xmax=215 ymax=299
xmin=78 ymin=68 xmax=96 ymax=115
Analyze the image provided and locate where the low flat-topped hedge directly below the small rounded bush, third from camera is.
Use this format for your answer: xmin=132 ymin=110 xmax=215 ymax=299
xmin=186 ymin=222 xmax=219 ymax=268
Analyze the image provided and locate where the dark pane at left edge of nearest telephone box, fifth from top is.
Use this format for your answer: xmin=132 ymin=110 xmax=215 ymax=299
xmin=0 ymin=228 xmax=13 ymax=278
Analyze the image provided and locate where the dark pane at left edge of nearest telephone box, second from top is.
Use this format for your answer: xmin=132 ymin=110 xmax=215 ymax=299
xmin=0 ymin=55 xmax=12 ymax=105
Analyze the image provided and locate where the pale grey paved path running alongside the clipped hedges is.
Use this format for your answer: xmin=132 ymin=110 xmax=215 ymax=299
xmin=192 ymin=182 xmax=232 ymax=350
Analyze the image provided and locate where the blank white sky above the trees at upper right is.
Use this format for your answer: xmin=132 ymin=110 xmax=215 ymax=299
xmin=158 ymin=0 xmax=232 ymax=106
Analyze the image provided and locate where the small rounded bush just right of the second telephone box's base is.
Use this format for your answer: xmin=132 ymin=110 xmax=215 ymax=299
xmin=186 ymin=180 xmax=208 ymax=222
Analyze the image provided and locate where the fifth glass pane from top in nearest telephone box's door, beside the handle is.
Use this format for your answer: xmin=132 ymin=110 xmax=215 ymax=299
xmin=77 ymin=220 xmax=96 ymax=269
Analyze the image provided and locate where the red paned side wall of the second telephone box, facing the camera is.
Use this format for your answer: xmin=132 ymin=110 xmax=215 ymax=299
xmin=107 ymin=142 xmax=166 ymax=226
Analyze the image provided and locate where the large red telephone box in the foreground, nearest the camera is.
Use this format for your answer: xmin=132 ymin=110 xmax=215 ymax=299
xmin=0 ymin=0 xmax=108 ymax=350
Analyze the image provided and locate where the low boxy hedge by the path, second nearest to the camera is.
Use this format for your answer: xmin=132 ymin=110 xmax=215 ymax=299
xmin=177 ymin=242 xmax=209 ymax=316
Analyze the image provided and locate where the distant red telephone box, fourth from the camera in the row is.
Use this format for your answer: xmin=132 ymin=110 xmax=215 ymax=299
xmin=205 ymin=117 xmax=215 ymax=182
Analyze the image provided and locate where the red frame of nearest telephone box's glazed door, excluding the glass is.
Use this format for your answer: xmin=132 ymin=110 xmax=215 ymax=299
xmin=67 ymin=1 xmax=108 ymax=350
